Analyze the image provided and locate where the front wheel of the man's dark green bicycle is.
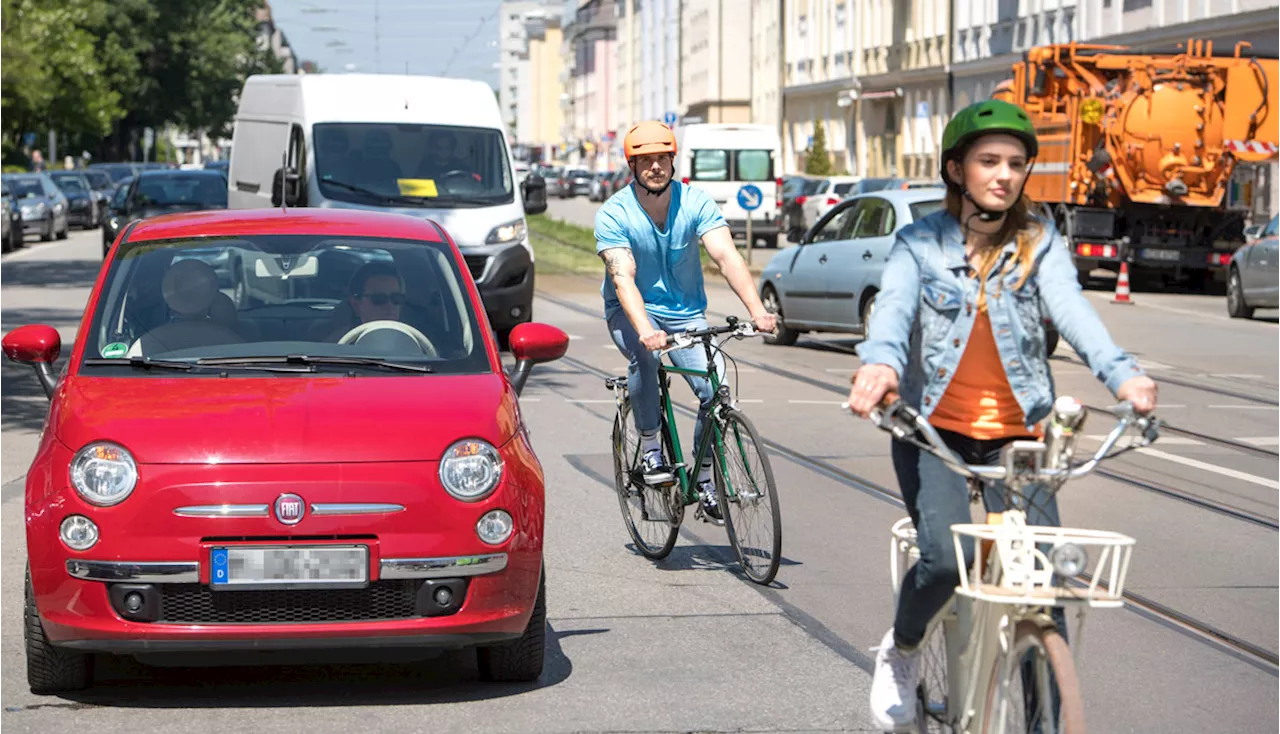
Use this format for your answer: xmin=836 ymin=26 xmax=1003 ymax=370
xmin=716 ymin=410 xmax=782 ymax=585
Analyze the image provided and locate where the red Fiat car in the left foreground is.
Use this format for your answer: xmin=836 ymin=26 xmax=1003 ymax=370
xmin=3 ymin=209 xmax=568 ymax=693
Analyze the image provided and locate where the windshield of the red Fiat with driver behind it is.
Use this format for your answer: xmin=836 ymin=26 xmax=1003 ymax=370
xmin=84 ymin=234 xmax=489 ymax=377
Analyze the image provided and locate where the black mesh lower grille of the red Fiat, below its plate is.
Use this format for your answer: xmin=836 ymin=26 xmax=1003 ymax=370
xmin=159 ymin=580 xmax=422 ymax=624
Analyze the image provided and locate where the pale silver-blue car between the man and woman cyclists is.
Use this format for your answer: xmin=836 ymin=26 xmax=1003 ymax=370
xmin=759 ymin=187 xmax=1059 ymax=355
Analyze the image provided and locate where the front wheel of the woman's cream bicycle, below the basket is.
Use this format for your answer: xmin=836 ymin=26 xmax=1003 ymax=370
xmin=980 ymin=621 xmax=1084 ymax=734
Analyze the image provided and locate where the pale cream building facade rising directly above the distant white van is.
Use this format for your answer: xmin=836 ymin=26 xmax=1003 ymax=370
xmin=680 ymin=0 xmax=751 ymax=123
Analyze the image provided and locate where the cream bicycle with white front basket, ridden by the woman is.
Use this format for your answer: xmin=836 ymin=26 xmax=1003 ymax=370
xmin=872 ymin=396 xmax=1160 ymax=734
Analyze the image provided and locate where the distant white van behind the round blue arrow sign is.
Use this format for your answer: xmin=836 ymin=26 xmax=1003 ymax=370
xmin=676 ymin=123 xmax=786 ymax=247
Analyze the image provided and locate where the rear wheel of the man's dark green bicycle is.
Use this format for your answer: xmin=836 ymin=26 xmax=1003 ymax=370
xmin=613 ymin=400 xmax=685 ymax=560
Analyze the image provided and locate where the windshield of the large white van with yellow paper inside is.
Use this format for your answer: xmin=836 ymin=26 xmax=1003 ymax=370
xmin=315 ymin=123 xmax=515 ymax=209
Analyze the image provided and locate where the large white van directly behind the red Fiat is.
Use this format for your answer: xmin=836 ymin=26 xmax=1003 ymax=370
xmin=227 ymin=74 xmax=545 ymax=342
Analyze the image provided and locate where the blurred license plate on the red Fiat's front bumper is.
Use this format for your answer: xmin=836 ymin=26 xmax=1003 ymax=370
xmin=210 ymin=546 xmax=369 ymax=589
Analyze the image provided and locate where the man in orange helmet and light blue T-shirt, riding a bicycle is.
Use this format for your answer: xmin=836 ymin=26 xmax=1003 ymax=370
xmin=595 ymin=122 xmax=774 ymax=524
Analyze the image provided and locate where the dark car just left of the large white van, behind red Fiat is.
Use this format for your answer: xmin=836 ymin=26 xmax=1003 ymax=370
xmin=102 ymin=169 xmax=227 ymax=257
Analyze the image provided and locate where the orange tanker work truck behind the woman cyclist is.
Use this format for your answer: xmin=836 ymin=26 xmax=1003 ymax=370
xmin=993 ymin=40 xmax=1280 ymax=290
